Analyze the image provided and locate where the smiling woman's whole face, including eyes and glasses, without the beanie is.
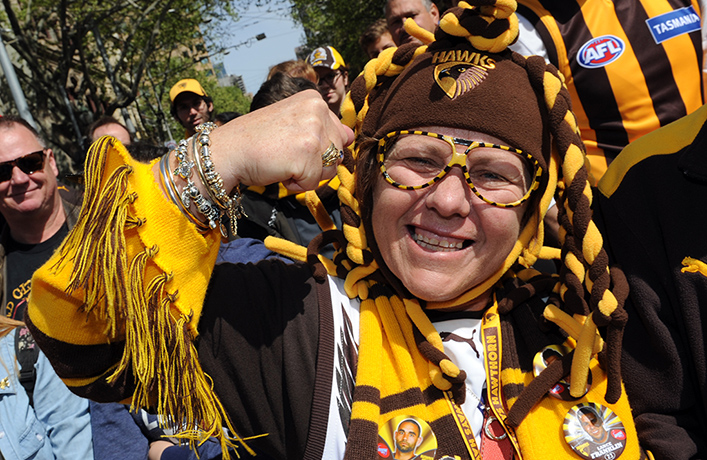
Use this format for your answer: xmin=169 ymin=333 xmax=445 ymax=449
xmin=371 ymin=127 xmax=534 ymax=304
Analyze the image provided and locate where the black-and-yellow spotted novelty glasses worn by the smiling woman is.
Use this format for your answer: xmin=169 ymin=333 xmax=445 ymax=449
xmin=378 ymin=131 xmax=542 ymax=207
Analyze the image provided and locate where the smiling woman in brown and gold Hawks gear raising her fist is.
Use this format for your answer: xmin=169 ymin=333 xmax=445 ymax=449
xmin=29 ymin=0 xmax=644 ymax=460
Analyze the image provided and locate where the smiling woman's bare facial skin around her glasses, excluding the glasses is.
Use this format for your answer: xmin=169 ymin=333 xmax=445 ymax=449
xmin=372 ymin=127 xmax=527 ymax=302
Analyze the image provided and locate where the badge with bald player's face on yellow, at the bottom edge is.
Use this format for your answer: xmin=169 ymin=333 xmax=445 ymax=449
xmin=377 ymin=415 xmax=437 ymax=460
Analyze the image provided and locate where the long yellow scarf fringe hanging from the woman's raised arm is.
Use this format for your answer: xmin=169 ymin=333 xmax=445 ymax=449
xmin=52 ymin=138 xmax=254 ymax=460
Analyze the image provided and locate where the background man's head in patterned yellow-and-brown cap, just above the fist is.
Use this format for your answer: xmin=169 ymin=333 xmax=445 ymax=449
xmin=307 ymin=46 xmax=349 ymax=115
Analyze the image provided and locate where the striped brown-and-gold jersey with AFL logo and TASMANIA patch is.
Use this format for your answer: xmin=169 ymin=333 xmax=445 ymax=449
xmin=512 ymin=0 xmax=704 ymax=185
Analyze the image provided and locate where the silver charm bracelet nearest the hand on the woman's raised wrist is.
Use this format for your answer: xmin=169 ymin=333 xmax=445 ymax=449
xmin=194 ymin=122 xmax=247 ymax=238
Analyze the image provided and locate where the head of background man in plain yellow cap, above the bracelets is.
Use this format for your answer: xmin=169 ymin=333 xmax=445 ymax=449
xmin=169 ymin=78 xmax=214 ymax=137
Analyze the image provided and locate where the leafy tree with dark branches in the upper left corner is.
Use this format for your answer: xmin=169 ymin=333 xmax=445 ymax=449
xmin=0 ymin=0 xmax=248 ymax=171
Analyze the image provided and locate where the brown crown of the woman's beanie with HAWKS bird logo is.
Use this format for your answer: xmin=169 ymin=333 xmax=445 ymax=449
xmin=362 ymin=42 xmax=549 ymax=174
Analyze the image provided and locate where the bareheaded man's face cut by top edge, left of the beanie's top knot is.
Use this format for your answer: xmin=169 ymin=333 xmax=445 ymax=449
xmin=385 ymin=0 xmax=439 ymax=46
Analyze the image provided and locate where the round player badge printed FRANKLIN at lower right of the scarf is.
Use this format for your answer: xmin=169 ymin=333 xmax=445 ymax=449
xmin=562 ymin=403 xmax=626 ymax=460
